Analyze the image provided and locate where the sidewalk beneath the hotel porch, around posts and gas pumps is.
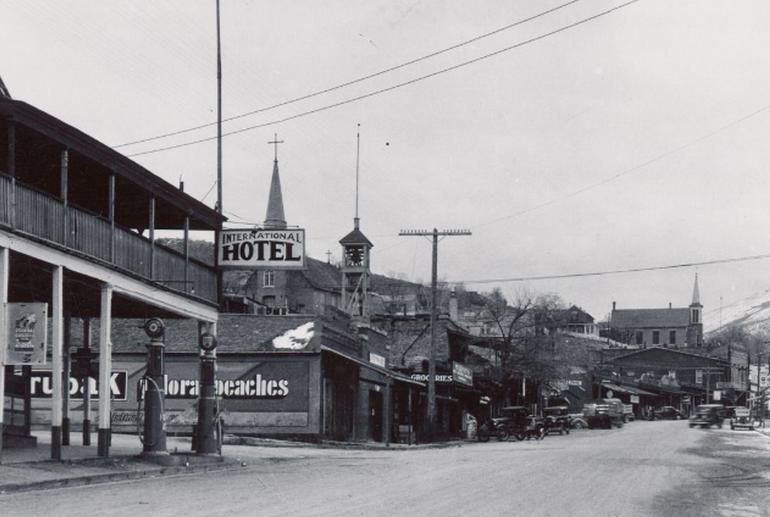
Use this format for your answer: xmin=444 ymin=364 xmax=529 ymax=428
xmin=0 ymin=432 xmax=242 ymax=494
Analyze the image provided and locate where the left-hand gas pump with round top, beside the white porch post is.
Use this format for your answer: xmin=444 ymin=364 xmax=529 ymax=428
xmin=142 ymin=318 xmax=168 ymax=456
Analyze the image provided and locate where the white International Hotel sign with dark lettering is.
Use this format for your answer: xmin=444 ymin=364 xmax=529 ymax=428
xmin=217 ymin=228 xmax=305 ymax=269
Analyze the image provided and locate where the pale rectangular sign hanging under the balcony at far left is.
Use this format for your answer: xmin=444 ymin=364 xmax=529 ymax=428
xmin=5 ymin=303 xmax=48 ymax=365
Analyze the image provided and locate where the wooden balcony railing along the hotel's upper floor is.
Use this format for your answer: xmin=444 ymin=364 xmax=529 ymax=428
xmin=0 ymin=175 xmax=217 ymax=303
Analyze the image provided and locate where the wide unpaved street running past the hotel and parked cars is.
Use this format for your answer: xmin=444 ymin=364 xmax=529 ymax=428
xmin=0 ymin=421 xmax=770 ymax=517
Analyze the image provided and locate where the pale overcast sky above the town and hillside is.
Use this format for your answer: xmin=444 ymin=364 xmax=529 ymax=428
xmin=0 ymin=0 xmax=770 ymax=326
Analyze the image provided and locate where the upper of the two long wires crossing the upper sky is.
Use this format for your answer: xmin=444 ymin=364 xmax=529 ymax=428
xmin=113 ymin=0 xmax=581 ymax=149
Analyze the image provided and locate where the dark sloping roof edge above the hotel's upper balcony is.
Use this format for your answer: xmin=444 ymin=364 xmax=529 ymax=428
xmin=0 ymin=98 xmax=227 ymax=229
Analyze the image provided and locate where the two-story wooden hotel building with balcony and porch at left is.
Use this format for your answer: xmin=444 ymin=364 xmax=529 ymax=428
xmin=0 ymin=91 xmax=224 ymax=459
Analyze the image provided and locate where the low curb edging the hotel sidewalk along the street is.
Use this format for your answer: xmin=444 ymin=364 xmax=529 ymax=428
xmin=0 ymin=461 xmax=246 ymax=495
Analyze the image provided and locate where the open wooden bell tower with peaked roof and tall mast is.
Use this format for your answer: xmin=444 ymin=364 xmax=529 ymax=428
xmin=340 ymin=124 xmax=374 ymax=319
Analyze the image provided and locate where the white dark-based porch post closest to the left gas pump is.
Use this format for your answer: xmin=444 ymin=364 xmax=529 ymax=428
xmin=97 ymin=284 xmax=112 ymax=458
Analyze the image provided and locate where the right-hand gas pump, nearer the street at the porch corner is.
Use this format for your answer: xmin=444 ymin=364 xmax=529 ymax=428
xmin=195 ymin=332 xmax=222 ymax=454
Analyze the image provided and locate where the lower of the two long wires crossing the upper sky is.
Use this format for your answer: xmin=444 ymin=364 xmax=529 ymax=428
xmin=127 ymin=0 xmax=640 ymax=157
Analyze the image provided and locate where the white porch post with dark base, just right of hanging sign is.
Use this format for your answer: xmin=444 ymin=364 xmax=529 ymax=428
xmin=51 ymin=266 xmax=64 ymax=461
